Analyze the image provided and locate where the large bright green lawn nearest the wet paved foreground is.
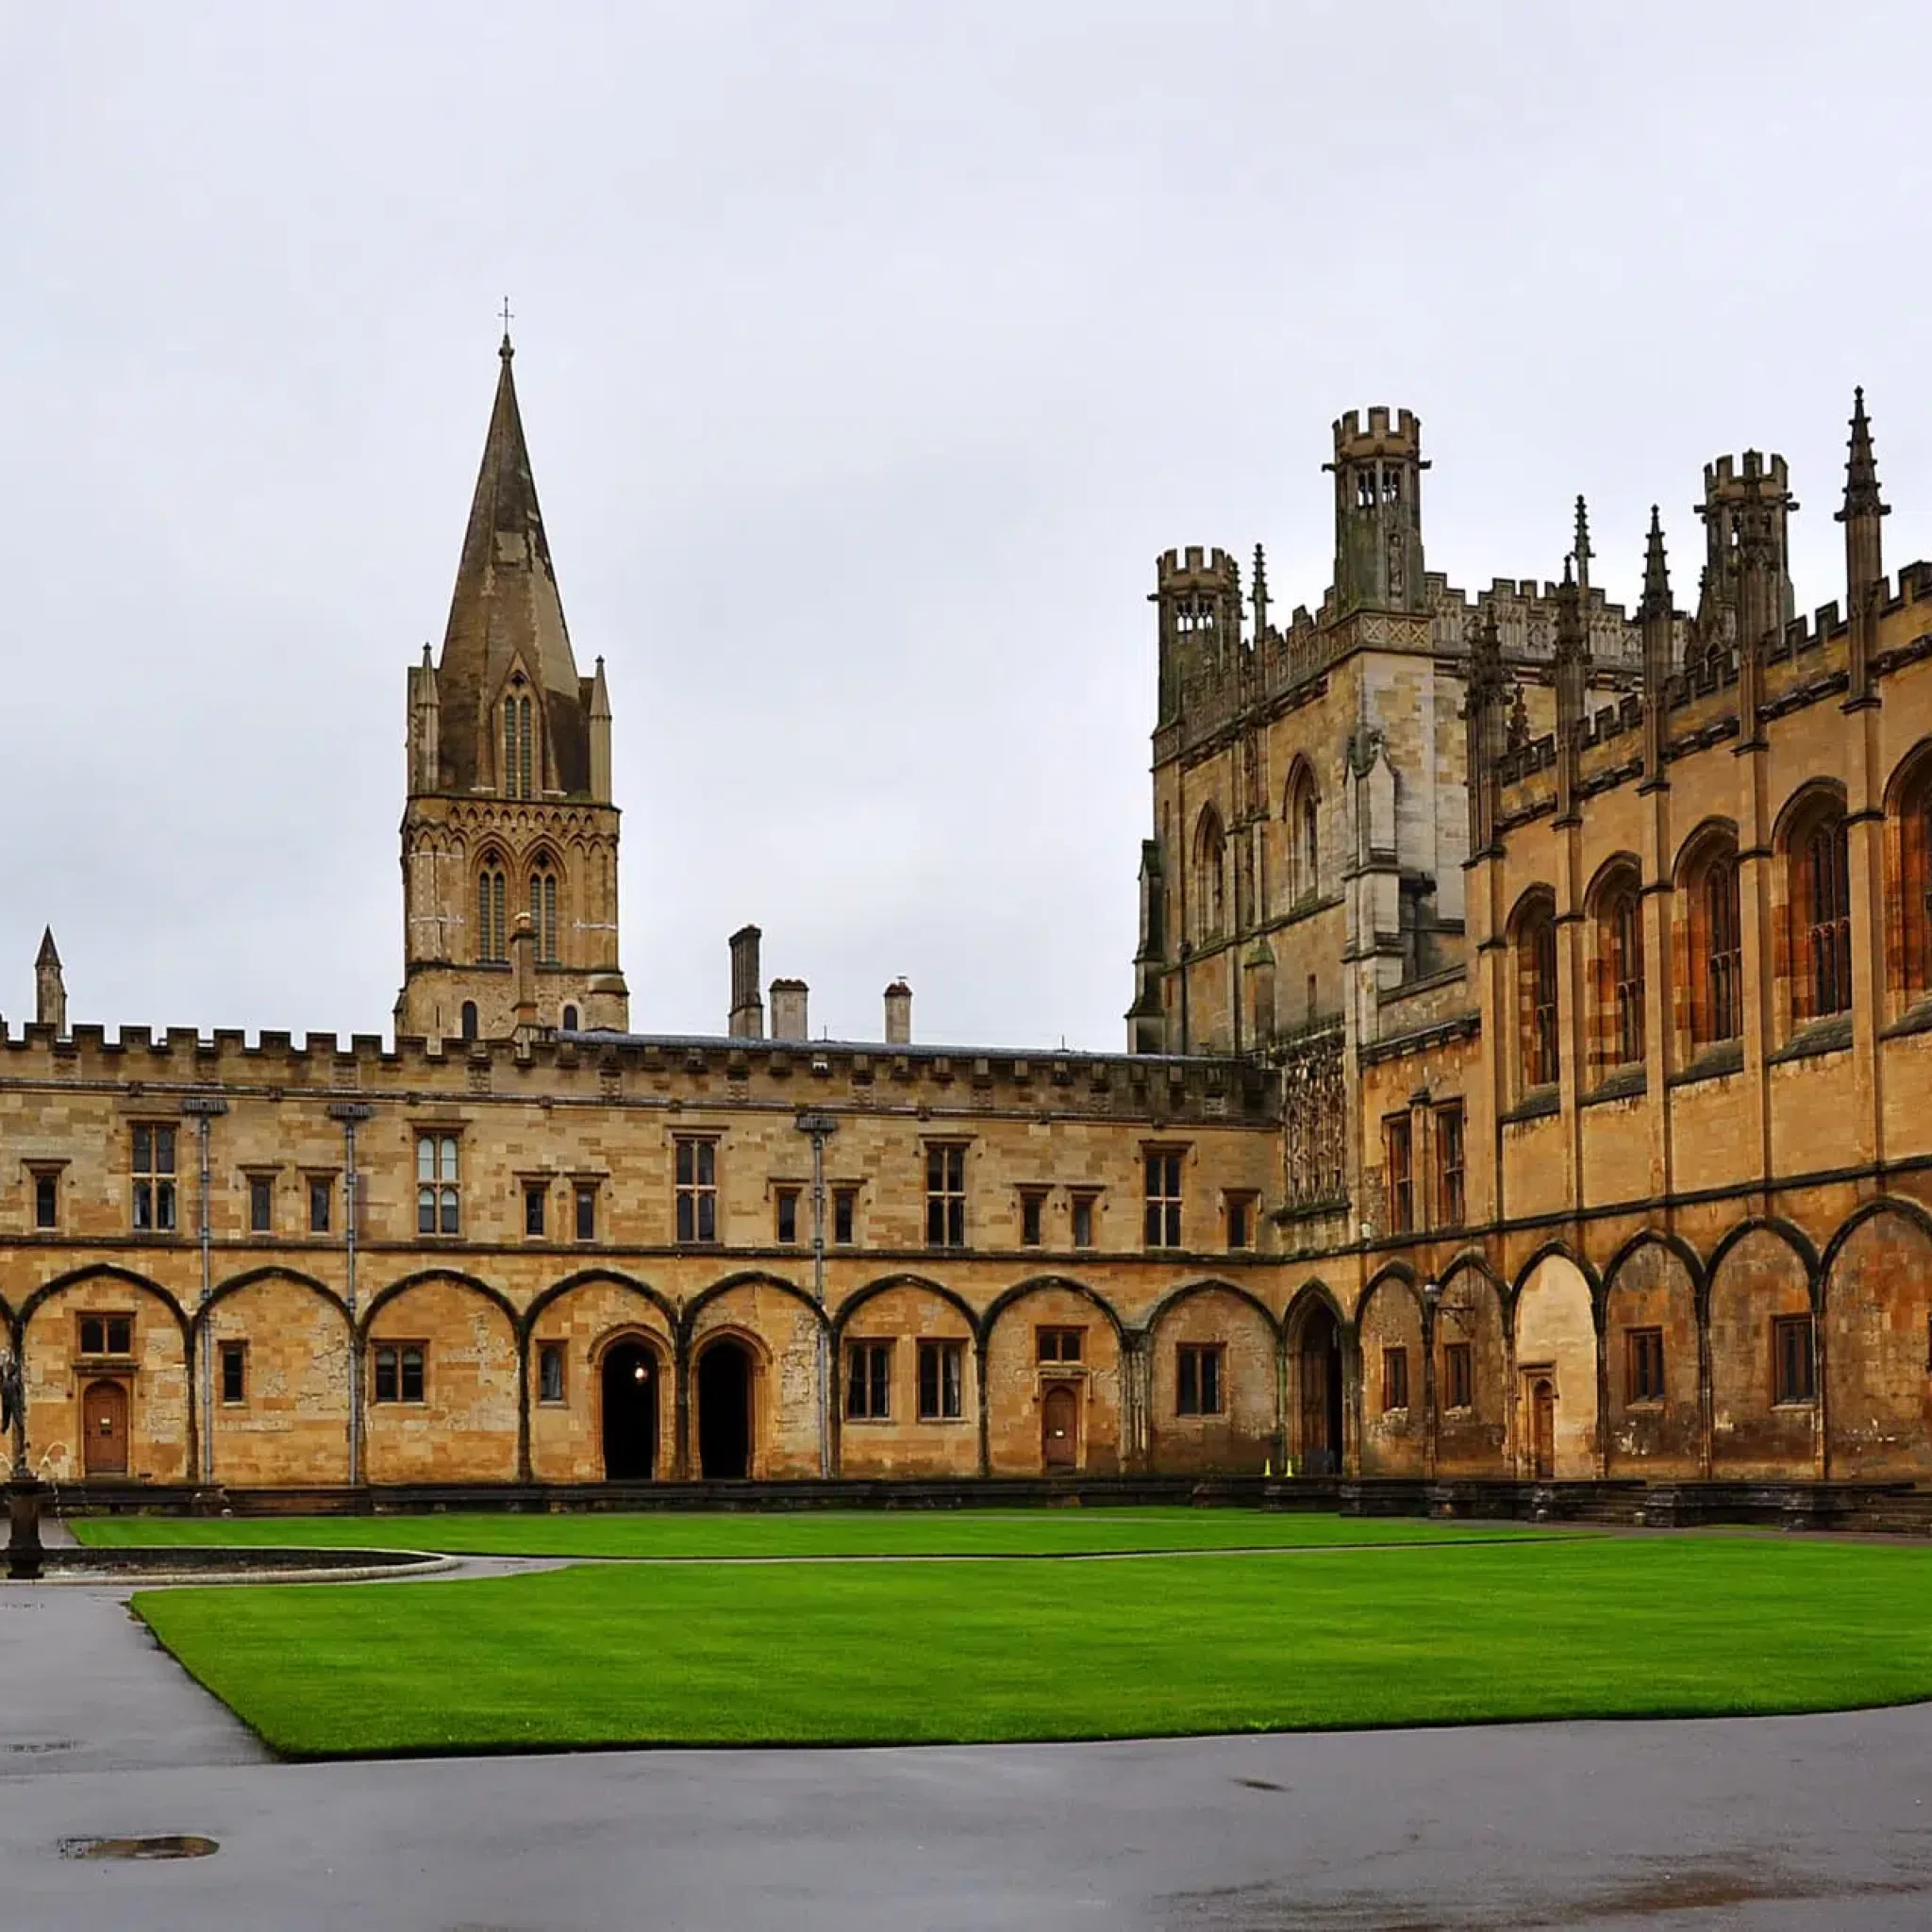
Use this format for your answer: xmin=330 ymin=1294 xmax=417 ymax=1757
xmin=133 ymin=1538 xmax=1932 ymax=1757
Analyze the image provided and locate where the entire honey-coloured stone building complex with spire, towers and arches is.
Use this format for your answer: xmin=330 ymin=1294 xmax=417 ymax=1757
xmin=0 ymin=358 xmax=1932 ymax=1490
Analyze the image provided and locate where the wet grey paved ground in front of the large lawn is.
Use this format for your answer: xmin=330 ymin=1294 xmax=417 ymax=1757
xmin=0 ymin=1586 xmax=1932 ymax=1932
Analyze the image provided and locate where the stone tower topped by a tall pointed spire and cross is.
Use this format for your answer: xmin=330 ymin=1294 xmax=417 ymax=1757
xmin=396 ymin=336 xmax=630 ymax=1040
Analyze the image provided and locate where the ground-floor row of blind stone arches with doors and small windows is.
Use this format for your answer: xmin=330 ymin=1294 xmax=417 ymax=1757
xmin=0 ymin=1196 xmax=1932 ymax=1488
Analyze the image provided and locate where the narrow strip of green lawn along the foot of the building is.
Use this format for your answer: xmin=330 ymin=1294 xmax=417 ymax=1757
xmin=70 ymin=1507 xmax=1536 ymax=1557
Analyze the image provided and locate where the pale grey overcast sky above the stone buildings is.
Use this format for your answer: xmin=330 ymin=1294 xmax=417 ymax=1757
xmin=0 ymin=0 xmax=1932 ymax=1049
